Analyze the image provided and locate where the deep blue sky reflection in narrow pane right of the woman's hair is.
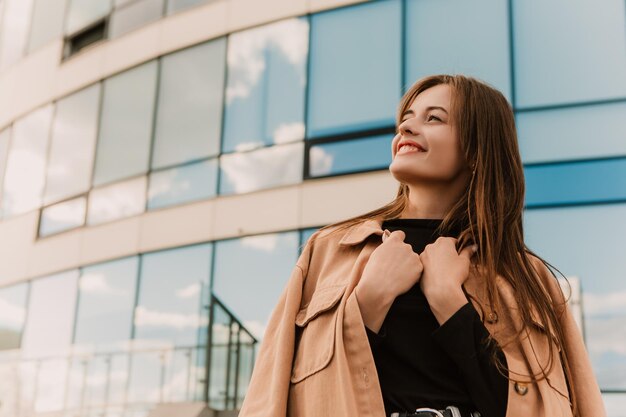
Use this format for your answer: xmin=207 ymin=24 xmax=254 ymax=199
xmin=524 ymin=158 xmax=626 ymax=207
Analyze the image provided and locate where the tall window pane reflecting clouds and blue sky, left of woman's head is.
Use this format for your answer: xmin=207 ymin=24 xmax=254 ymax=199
xmin=222 ymin=19 xmax=309 ymax=152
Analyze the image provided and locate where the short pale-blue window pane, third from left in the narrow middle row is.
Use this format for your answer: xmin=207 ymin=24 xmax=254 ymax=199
xmin=148 ymin=159 xmax=217 ymax=210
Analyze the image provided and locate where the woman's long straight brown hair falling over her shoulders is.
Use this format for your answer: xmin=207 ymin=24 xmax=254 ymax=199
xmin=310 ymin=74 xmax=578 ymax=416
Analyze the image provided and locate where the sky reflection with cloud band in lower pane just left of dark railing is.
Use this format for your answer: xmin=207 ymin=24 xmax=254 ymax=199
xmin=135 ymin=244 xmax=211 ymax=346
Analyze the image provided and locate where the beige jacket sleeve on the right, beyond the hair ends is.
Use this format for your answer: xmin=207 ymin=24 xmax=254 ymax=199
xmin=537 ymin=260 xmax=606 ymax=417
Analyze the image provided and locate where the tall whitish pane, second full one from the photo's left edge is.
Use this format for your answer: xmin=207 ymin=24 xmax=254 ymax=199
xmin=44 ymin=84 xmax=100 ymax=204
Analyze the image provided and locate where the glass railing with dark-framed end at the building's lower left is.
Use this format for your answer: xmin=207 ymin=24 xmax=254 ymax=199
xmin=0 ymin=296 xmax=258 ymax=417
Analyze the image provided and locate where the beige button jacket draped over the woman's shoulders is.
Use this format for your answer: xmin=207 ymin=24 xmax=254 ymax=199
xmin=239 ymin=220 xmax=606 ymax=417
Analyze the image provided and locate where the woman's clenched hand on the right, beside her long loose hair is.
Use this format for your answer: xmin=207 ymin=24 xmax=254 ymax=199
xmin=420 ymin=236 xmax=476 ymax=324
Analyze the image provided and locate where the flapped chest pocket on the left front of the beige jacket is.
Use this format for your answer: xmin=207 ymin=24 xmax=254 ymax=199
xmin=291 ymin=286 xmax=345 ymax=383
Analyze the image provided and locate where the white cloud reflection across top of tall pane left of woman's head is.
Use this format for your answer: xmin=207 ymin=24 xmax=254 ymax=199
xmin=226 ymin=18 xmax=309 ymax=105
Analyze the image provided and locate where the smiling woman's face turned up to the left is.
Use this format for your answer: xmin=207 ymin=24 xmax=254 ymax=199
xmin=389 ymin=84 xmax=467 ymax=184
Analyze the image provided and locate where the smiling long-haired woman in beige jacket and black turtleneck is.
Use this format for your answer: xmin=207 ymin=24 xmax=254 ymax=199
xmin=239 ymin=75 xmax=605 ymax=417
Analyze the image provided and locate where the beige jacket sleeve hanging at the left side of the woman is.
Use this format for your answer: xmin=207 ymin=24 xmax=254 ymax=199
xmin=239 ymin=232 xmax=317 ymax=417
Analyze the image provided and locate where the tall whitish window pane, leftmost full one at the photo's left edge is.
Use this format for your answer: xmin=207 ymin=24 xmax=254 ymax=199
xmin=2 ymin=105 xmax=52 ymax=218
